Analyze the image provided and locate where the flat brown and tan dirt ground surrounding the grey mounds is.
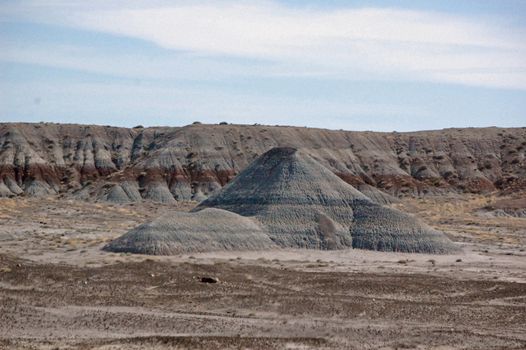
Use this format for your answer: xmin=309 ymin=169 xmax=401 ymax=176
xmin=0 ymin=195 xmax=526 ymax=350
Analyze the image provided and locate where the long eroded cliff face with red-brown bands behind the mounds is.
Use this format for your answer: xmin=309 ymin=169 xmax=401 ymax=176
xmin=0 ymin=123 xmax=526 ymax=202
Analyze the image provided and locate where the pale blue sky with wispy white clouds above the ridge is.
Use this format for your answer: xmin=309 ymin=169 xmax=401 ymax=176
xmin=0 ymin=0 xmax=526 ymax=131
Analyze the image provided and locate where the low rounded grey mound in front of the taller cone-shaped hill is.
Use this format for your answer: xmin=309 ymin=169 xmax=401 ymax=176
xmin=103 ymin=208 xmax=276 ymax=255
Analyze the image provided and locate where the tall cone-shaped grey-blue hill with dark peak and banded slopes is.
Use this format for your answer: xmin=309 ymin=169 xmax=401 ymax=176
xmin=193 ymin=147 xmax=456 ymax=253
